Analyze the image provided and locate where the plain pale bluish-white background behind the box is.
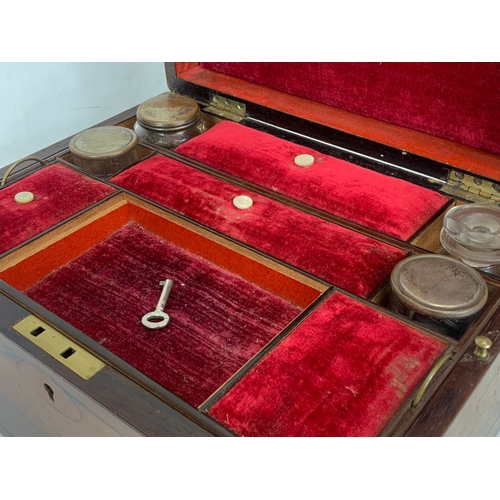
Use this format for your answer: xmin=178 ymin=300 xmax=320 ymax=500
xmin=0 ymin=62 xmax=168 ymax=168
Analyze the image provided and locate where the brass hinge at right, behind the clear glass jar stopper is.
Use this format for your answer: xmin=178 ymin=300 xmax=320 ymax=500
xmin=441 ymin=170 xmax=500 ymax=205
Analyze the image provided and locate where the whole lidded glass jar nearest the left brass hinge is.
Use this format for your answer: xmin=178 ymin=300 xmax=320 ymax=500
xmin=134 ymin=92 xmax=207 ymax=148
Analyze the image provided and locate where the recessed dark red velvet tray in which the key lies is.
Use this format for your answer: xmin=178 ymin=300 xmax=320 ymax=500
xmin=0 ymin=195 xmax=325 ymax=406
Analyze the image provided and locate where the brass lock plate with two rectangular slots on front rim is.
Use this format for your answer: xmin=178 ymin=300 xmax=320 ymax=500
xmin=12 ymin=315 xmax=106 ymax=380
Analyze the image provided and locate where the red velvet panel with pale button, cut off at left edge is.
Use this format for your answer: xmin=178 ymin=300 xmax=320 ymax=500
xmin=0 ymin=163 xmax=115 ymax=254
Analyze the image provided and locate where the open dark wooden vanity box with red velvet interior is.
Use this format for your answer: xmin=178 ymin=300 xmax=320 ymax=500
xmin=0 ymin=63 xmax=500 ymax=436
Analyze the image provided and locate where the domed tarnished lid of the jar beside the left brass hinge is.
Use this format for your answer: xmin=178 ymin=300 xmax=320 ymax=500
xmin=137 ymin=93 xmax=201 ymax=131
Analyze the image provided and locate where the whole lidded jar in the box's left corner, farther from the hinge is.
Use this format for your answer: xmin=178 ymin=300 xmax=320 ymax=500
xmin=69 ymin=126 xmax=140 ymax=177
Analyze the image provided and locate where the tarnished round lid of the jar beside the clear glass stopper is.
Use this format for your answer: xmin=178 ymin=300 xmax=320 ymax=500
xmin=391 ymin=255 xmax=488 ymax=319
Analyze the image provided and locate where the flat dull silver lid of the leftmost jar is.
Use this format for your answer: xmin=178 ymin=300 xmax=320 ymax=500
xmin=69 ymin=127 xmax=139 ymax=160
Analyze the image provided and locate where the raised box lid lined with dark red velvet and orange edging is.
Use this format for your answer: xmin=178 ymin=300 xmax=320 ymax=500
xmin=166 ymin=63 xmax=500 ymax=179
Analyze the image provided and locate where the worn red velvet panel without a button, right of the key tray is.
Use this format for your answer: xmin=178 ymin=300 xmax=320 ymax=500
xmin=209 ymin=293 xmax=445 ymax=436
